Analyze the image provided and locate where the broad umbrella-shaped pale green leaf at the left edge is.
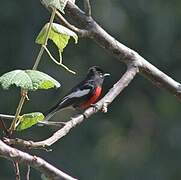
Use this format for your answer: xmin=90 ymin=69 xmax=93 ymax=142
xmin=0 ymin=70 xmax=60 ymax=91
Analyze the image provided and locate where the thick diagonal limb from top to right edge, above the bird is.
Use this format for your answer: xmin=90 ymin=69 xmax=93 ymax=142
xmin=65 ymin=1 xmax=181 ymax=99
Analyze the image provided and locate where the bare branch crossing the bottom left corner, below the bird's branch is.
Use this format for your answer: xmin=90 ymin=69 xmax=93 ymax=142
xmin=0 ymin=140 xmax=76 ymax=180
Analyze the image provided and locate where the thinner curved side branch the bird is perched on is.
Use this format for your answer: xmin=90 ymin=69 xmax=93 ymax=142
xmin=4 ymin=65 xmax=138 ymax=148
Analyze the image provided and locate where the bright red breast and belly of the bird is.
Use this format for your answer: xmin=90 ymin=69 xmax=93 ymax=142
xmin=80 ymin=86 xmax=102 ymax=109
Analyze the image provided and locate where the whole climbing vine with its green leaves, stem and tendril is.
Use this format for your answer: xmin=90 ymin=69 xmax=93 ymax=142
xmin=0 ymin=0 xmax=78 ymax=134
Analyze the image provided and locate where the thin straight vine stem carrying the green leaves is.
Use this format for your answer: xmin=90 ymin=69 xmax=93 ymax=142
xmin=8 ymin=7 xmax=56 ymax=135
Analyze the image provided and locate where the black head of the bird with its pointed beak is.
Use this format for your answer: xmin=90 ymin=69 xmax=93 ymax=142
xmin=87 ymin=66 xmax=110 ymax=84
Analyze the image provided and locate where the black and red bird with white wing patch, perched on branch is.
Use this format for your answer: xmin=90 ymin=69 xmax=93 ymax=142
xmin=45 ymin=66 xmax=110 ymax=121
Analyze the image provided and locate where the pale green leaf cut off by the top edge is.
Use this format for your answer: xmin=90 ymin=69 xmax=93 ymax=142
xmin=42 ymin=0 xmax=68 ymax=13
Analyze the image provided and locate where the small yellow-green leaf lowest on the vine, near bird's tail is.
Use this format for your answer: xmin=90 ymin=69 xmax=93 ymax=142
xmin=16 ymin=112 xmax=45 ymax=131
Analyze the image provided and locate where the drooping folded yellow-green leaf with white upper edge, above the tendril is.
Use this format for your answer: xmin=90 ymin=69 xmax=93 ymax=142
xmin=36 ymin=23 xmax=78 ymax=60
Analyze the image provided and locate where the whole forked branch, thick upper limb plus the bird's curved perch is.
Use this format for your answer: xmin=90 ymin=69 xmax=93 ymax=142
xmin=2 ymin=1 xmax=181 ymax=148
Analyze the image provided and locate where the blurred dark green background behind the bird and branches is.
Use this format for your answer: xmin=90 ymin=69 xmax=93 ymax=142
xmin=0 ymin=0 xmax=181 ymax=180
